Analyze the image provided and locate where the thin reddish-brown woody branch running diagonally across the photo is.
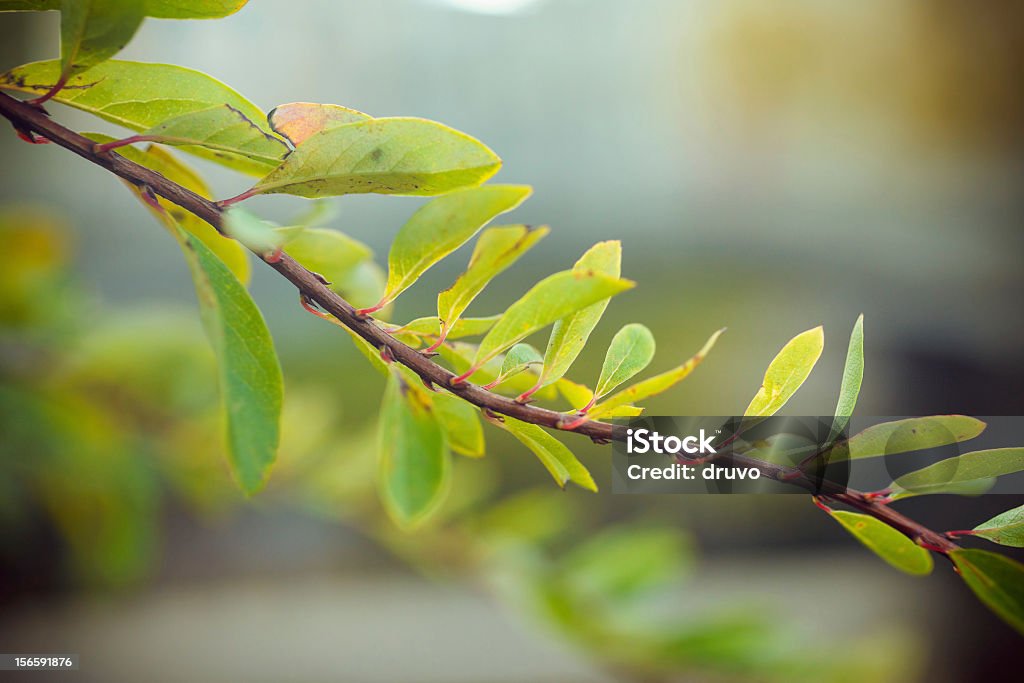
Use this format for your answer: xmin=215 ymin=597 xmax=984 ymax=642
xmin=0 ymin=92 xmax=957 ymax=553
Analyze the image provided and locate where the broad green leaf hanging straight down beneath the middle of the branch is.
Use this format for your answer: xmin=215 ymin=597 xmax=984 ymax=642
xmin=378 ymin=373 xmax=452 ymax=529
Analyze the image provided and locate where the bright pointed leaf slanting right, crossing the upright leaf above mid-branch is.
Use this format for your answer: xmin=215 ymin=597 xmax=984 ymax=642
xmin=473 ymin=270 xmax=634 ymax=378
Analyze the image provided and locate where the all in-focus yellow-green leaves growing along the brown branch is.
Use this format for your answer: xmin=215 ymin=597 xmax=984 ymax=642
xmin=0 ymin=0 xmax=1024 ymax=630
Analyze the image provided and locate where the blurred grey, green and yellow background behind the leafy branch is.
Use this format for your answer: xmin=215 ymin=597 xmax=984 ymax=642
xmin=0 ymin=0 xmax=1024 ymax=682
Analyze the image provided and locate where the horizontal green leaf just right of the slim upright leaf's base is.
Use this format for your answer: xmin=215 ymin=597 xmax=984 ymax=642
xmin=848 ymin=415 xmax=985 ymax=460
